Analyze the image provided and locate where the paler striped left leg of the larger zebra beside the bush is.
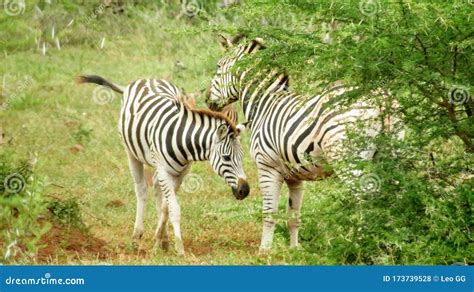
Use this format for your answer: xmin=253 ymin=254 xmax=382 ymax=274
xmin=258 ymin=168 xmax=283 ymax=253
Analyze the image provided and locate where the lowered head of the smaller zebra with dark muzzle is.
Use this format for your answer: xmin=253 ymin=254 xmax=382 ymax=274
xmin=209 ymin=120 xmax=250 ymax=200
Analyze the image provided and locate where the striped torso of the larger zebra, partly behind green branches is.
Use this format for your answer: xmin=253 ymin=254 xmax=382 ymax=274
xmin=244 ymin=86 xmax=380 ymax=180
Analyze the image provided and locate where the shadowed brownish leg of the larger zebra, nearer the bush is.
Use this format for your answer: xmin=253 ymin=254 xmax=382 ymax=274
xmin=286 ymin=181 xmax=304 ymax=247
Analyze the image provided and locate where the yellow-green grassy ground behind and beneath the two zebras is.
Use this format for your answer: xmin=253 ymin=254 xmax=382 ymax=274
xmin=0 ymin=4 xmax=342 ymax=264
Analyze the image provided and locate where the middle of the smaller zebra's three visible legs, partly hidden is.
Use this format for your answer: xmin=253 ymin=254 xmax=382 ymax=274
xmin=153 ymin=179 xmax=169 ymax=250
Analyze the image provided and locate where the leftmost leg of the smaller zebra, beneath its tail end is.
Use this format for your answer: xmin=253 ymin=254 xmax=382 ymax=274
xmin=127 ymin=151 xmax=147 ymax=239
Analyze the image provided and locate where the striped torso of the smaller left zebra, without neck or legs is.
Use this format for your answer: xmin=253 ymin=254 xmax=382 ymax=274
xmin=119 ymin=79 xmax=182 ymax=169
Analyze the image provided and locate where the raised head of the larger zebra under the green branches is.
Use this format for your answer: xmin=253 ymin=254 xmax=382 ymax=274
xmin=206 ymin=35 xmax=264 ymax=111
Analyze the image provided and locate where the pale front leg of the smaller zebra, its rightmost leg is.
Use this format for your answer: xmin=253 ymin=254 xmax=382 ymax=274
xmin=157 ymin=173 xmax=184 ymax=255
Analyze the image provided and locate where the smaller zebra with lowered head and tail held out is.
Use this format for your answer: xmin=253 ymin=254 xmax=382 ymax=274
xmin=77 ymin=76 xmax=250 ymax=255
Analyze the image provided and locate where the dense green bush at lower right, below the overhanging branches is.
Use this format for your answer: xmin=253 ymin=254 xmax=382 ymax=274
xmin=301 ymin=134 xmax=474 ymax=264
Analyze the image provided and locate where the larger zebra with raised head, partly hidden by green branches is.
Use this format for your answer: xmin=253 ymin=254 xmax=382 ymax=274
xmin=206 ymin=35 xmax=402 ymax=252
